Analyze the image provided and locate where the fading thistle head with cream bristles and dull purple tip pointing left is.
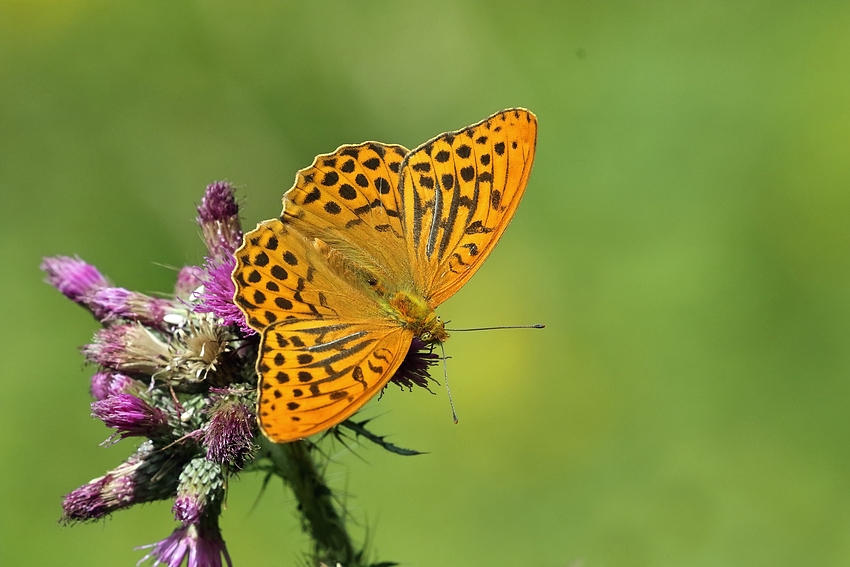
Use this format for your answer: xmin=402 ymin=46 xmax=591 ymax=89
xmin=82 ymin=323 xmax=172 ymax=375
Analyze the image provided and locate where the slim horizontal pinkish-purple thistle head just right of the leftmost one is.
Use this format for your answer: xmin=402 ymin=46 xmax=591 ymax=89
xmin=84 ymin=287 xmax=185 ymax=327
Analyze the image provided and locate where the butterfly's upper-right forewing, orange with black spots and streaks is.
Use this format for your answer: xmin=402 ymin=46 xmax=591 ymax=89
xmin=399 ymin=109 xmax=537 ymax=306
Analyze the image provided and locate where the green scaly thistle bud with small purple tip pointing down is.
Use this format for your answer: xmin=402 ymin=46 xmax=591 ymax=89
xmin=172 ymin=457 xmax=224 ymax=525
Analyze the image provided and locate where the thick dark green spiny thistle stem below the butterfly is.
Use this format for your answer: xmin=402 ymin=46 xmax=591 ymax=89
xmin=262 ymin=438 xmax=360 ymax=567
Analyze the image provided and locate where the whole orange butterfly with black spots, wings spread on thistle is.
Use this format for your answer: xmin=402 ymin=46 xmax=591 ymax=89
xmin=232 ymin=108 xmax=537 ymax=443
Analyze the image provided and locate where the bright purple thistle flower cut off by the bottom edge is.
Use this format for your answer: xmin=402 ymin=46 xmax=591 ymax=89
xmin=136 ymin=521 xmax=233 ymax=567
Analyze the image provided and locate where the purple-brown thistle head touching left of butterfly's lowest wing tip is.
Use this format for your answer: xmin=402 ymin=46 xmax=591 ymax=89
xmin=204 ymin=398 xmax=257 ymax=469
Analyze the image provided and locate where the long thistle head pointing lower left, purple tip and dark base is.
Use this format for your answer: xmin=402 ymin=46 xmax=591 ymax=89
xmin=62 ymin=441 xmax=178 ymax=522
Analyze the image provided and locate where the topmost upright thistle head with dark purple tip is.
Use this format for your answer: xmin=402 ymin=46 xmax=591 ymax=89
xmin=197 ymin=181 xmax=242 ymax=260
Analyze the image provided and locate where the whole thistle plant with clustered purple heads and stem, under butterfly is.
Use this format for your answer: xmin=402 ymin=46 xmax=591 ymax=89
xmin=48 ymin=183 xmax=408 ymax=567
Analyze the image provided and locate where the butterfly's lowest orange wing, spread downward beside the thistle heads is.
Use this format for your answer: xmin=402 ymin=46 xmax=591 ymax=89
xmin=257 ymin=319 xmax=412 ymax=443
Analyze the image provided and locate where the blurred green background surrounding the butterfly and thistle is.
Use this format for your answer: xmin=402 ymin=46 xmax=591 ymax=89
xmin=0 ymin=0 xmax=850 ymax=567
